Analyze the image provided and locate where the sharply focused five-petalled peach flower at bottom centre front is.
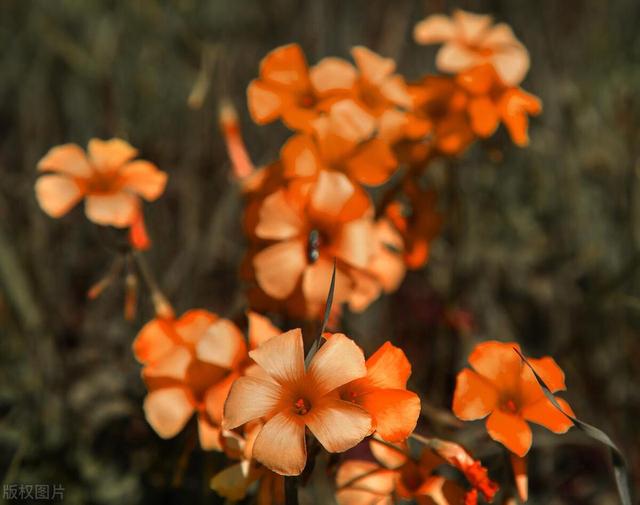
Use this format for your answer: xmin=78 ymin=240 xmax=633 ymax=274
xmin=223 ymin=329 xmax=371 ymax=475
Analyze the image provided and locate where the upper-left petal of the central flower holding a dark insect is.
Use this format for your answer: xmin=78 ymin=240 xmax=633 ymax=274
xmin=255 ymin=189 xmax=303 ymax=240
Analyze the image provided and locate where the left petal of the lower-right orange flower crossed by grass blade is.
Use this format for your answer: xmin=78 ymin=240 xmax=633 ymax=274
xmin=453 ymin=368 xmax=498 ymax=421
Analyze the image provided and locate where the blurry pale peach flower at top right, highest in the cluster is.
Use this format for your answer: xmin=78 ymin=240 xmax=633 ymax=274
xmin=414 ymin=10 xmax=529 ymax=86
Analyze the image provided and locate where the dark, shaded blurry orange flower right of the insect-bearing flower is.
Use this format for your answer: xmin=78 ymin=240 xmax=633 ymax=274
xmin=385 ymin=180 xmax=442 ymax=269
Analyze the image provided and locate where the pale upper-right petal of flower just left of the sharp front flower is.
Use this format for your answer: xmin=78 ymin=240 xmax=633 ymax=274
xmin=196 ymin=319 xmax=247 ymax=368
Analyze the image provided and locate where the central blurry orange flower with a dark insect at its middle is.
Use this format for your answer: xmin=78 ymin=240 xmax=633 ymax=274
xmin=253 ymin=171 xmax=372 ymax=307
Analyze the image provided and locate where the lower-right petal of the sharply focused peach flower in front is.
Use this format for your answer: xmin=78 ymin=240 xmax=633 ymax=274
xmin=304 ymin=398 xmax=371 ymax=452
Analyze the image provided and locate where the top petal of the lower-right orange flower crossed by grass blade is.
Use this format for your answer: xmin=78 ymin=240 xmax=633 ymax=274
xmin=469 ymin=340 xmax=522 ymax=391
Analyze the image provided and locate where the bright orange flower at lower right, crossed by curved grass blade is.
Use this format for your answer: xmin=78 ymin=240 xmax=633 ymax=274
xmin=453 ymin=341 xmax=573 ymax=457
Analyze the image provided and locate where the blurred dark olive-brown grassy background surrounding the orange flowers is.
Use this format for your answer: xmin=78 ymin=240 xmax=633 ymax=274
xmin=0 ymin=0 xmax=640 ymax=505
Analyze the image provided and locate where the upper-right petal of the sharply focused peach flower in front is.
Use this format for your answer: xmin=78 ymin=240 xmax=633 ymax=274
xmin=308 ymin=333 xmax=367 ymax=395
